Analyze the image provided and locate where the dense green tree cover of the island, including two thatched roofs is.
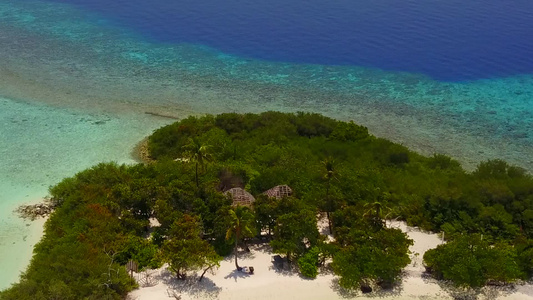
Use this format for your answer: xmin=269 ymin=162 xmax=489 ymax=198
xmin=0 ymin=112 xmax=533 ymax=299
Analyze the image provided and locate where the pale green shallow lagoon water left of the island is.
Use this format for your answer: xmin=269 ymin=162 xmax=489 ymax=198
xmin=0 ymin=98 xmax=168 ymax=289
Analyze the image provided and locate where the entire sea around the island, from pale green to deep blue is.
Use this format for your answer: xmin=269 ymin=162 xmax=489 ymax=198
xmin=0 ymin=0 xmax=533 ymax=289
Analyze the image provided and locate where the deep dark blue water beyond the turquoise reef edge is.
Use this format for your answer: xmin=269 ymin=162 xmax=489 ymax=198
xmin=44 ymin=0 xmax=533 ymax=81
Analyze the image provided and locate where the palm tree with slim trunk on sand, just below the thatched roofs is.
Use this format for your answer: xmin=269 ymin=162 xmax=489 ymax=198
xmin=226 ymin=205 xmax=255 ymax=270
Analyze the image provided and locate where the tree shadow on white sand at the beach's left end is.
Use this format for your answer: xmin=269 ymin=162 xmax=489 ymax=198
xmin=157 ymin=270 xmax=222 ymax=299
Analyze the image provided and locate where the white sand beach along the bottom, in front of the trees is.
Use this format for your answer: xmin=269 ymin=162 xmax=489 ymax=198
xmin=129 ymin=221 xmax=533 ymax=300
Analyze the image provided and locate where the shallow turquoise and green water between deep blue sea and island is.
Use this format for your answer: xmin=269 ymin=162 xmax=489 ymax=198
xmin=0 ymin=0 xmax=533 ymax=288
